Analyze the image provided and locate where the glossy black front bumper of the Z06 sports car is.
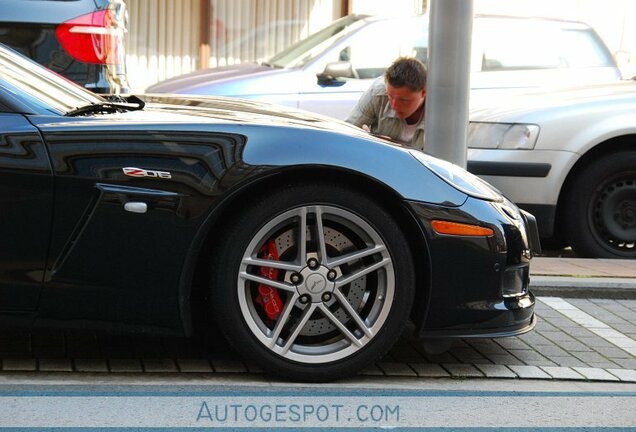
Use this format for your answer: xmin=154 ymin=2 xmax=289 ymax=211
xmin=409 ymin=198 xmax=540 ymax=338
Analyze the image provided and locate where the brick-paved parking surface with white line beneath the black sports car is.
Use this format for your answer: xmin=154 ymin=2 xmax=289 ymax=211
xmin=0 ymin=297 xmax=636 ymax=382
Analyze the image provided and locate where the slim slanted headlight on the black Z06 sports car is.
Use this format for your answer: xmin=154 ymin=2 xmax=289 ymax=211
xmin=409 ymin=150 xmax=503 ymax=202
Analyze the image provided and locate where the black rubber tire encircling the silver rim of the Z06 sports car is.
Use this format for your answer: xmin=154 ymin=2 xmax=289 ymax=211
xmin=211 ymin=185 xmax=414 ymax=381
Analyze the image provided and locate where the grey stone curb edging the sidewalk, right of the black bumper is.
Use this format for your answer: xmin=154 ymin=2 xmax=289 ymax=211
xmin=530 ymin=275 xmax=636 ymax=300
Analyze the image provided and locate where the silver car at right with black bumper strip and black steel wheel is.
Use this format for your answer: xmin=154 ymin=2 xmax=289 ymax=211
xmin=468 ymin=81 xmax=636 ymax=259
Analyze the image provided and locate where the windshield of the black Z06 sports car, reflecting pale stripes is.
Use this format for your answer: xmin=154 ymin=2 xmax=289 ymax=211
xmin=0 ymin=44 xmax=104 ymax=113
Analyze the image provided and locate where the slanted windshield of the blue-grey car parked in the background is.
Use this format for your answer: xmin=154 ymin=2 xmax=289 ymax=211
xmin=267 ymin=15 xmax=365 ymax=68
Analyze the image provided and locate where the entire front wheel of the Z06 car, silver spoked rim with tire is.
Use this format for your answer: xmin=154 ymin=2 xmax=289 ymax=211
xmin=211 ymin=184 xmax=414 ymax=382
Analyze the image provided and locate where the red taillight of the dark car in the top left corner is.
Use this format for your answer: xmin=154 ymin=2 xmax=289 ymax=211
xmin=55 ymin=9 xmax=124 ymax=64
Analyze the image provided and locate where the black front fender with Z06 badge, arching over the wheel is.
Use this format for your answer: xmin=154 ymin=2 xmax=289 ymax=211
xmin=23 ymin=111 xmax=448 ymax=331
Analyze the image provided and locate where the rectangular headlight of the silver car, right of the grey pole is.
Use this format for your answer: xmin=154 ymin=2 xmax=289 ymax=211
xmin=468 ymin=122 xmax=539 ymax=150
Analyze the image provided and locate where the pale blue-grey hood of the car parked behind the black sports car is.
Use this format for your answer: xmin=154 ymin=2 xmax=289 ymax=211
xmin=147 ymin=63 xmax=298 ymax=96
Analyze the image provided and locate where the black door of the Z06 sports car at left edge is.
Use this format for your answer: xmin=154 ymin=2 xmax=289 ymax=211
xmin=0 ymin=113 xmax=53 ymax=312
